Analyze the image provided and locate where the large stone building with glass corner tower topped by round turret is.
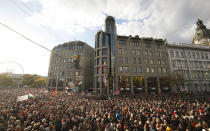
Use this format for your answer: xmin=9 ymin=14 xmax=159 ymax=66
xmin=94 ymin=16 xmax=170 ymax=95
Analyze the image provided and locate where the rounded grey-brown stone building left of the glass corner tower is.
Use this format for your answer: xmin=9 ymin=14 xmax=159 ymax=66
xmin=47 ymin=41 xmax=94 ymax=90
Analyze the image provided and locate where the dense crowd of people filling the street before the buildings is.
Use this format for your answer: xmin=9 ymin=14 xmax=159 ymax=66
xmin=0 ymin=88 xmax=210 ymax=131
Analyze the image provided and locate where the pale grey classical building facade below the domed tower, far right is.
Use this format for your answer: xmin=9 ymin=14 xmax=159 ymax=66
xmin=167 ymin=44 xmax=210 ymax=93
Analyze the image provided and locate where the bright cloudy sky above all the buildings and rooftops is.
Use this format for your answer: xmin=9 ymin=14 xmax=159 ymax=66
xmin=0 ymin=0 xmax=210 ymax=76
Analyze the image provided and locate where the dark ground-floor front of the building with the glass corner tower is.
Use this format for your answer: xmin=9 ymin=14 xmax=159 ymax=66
xmin=95 ymin=76 xmax=171 ymax=95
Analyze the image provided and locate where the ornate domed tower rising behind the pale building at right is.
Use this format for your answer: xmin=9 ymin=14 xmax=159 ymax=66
xmin=193 ymin=19 xmax=210 ymax=46
